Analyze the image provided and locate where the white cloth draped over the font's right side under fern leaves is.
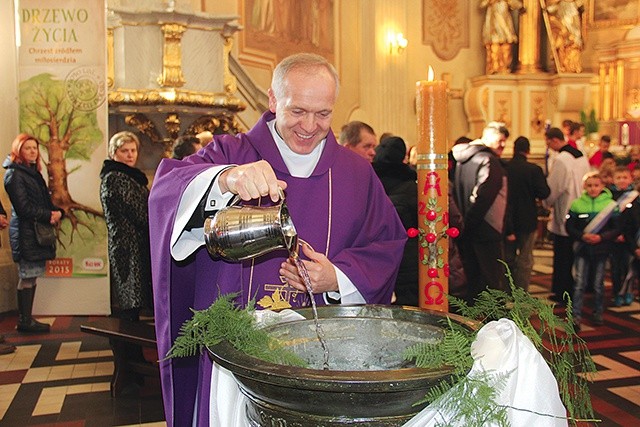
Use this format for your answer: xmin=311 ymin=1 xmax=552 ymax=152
xmin=404 ymin=319 xmax=567 ymax=427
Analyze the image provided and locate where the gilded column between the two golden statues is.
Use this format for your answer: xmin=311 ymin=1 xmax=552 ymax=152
xmin=516 ymin=0 xmax=542 ymax=74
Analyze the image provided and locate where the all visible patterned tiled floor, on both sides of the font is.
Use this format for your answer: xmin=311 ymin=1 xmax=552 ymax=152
xmin=0 ymin=246 xmax=640 ymax=427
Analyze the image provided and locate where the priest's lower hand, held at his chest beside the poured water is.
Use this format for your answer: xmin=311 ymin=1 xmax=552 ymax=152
xmin=280 ymin=243 xmax=339 ymax=294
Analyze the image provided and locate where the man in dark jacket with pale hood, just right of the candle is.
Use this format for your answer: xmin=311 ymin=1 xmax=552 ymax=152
xmin=452 ymin=122 xmax=509 ymax=304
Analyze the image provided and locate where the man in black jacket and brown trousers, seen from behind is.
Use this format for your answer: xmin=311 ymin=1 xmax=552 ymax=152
xmin=505 ymin=136 xmax=551 ymax=290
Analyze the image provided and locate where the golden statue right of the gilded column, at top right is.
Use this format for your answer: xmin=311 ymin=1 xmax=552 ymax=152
xmin=541 ymin=0 xmax=584 ymax=73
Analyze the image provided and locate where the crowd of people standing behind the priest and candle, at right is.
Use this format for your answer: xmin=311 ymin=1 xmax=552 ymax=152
xmin=340 ymin=114 xmax=640 ymax=334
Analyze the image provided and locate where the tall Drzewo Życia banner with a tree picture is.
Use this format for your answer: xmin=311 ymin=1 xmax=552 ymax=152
xmin=14 ymin=0 xmax=110 ymax=314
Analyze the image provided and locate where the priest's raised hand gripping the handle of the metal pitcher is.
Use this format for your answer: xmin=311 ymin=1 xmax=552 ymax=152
xmin=218 ymin=160 xmax=287 ymax=203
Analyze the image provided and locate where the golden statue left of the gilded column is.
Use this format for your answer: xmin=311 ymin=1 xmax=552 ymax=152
xmin=480 ymin=0 xmax=525 ymax=74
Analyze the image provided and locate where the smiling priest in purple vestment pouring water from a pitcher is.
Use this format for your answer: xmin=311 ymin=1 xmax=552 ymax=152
xmin=149 ymin=54 xmax=406 ymax=426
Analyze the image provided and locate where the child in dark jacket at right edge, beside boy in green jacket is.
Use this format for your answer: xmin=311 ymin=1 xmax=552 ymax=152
xmin=608 ymin=166 xmax=634 ymax=307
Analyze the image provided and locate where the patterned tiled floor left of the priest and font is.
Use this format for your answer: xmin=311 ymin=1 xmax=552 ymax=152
xmin=0 ymin=314 xmax=166 ymax=427
